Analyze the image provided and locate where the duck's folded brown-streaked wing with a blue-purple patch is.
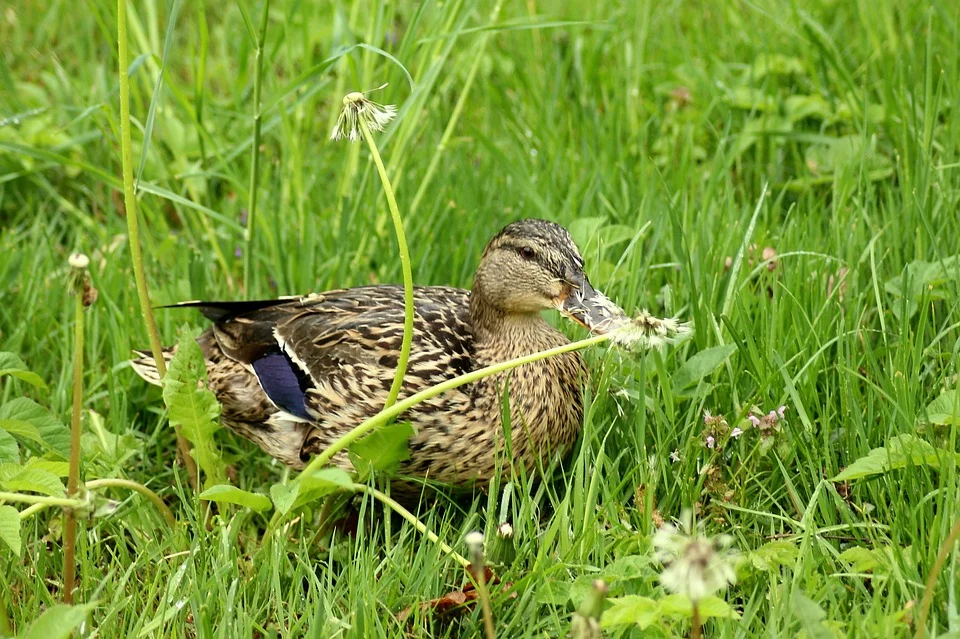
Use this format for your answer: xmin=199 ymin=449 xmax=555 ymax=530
xmin=194 ymin=286 xmax=472 ymax=421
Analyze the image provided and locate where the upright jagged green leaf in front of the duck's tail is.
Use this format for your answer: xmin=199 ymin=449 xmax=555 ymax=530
xmin=163 ymin=331 xmax=227 ymax=488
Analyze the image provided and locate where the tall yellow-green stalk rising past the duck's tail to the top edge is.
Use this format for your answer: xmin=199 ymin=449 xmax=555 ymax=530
xmin=117 ymin=0 xmax=199 ymax=490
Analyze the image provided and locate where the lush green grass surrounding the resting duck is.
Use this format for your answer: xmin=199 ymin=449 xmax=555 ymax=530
xmin=0 ymin=0 xmax=960 ymax=637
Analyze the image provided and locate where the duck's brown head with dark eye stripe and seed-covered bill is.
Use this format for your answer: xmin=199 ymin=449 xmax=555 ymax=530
xmin=473 ymin=219 xmax=622 ymax=330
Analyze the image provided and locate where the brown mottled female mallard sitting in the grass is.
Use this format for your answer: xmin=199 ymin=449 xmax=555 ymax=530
xmin=133 ymin=219 xmax=609 ymax=483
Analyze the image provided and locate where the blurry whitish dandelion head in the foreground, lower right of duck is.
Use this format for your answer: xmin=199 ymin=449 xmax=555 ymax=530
xmin=653 ymin=511 xmax=737 ymax=603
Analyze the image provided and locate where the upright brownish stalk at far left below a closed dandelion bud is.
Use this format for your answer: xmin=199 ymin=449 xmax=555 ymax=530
xmin=63 ymin=276 xmax=85 ymax=604
